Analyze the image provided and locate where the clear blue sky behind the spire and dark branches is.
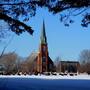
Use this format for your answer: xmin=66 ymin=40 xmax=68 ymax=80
xmin=0 ymin=9 xmax=90 ymax=60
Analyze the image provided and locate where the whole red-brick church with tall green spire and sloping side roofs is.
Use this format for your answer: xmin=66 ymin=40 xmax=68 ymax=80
xmin=30 ymin=21 xmax=54 ymax=73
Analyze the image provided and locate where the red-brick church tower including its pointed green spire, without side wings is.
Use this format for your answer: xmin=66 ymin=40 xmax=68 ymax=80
xmin=37 ymin=21 xmax=48 ymax=73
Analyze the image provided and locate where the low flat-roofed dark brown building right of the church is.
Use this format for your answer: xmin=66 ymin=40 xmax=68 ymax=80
xmin=60 ymin=61 xmax=80 ymax=73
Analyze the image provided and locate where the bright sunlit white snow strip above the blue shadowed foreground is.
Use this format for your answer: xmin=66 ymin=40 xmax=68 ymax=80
xmin=0 ymin=74 xmax=90 ymax=80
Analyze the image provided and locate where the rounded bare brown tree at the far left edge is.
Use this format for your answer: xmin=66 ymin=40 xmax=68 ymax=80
xmin=0 ymin=52 xmax=18 ymax=74
